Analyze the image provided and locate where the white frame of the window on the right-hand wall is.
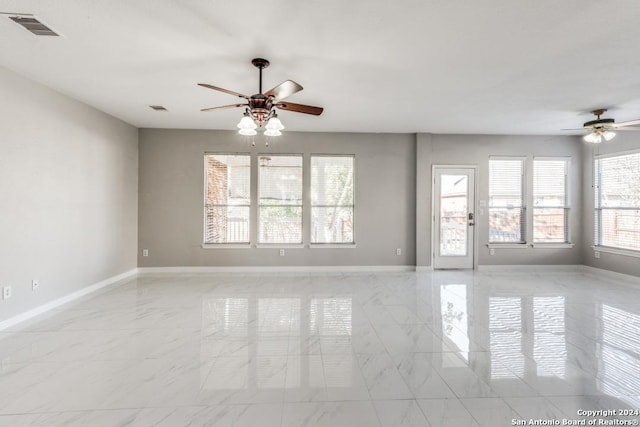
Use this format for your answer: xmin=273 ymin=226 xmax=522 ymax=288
xmin=591 ymin=150 xmax=640 ymax=258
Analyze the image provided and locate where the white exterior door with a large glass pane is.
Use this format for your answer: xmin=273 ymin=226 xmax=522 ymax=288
xmin=433 ymin=166 xmax=475 ymax=269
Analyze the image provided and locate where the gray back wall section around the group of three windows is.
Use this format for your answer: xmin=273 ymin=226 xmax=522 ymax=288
xmin=138 ymin=129 xmax=416 ymax=267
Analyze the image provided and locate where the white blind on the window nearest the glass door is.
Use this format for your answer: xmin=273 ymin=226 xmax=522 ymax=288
xmin=489 ymin=158 xmax=526 ymax=243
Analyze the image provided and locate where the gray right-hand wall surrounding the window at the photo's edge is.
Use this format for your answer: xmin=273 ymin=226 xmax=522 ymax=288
xmin=581 ymin=132 xmax=640 ymax=276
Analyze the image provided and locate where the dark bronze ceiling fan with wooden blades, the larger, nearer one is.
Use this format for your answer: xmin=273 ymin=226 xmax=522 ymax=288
xmin=198 ymin=58 xmax=323 ymax=136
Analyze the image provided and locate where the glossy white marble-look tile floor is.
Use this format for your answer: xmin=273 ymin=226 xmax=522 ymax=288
xmin=0 ymin=270 xmax=640 ymax=427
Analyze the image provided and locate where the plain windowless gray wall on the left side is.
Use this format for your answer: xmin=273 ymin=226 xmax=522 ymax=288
xmin=0 ymin=68 xmax=138 ymax=321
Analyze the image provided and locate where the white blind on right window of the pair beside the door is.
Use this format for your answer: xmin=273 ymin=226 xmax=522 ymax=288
xmin=533 ymin=159 xmax=569 ymax=243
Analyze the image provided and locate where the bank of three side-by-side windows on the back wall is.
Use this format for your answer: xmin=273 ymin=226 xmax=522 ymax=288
xmin=203 ymin=153 xmax=355 ymax=248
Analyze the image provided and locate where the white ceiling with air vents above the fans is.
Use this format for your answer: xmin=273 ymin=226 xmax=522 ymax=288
xmin=0 ymin=0 xmax=640 ymax=134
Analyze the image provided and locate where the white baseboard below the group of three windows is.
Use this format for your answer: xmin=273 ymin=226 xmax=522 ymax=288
xmin=138 ymin=265 xmax=416 ymax=275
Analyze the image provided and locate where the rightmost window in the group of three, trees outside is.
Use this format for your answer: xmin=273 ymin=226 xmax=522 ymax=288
xmin=311 ymin=156 xmax=354 ymax=243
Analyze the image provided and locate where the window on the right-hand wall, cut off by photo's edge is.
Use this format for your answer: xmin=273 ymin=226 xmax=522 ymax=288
xmin=594 ymin=153 xmax=640 ymax=251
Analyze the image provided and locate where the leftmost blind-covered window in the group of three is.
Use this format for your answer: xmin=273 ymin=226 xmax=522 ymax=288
xmin=204 ymin=154 xmax=251 ymax=243
